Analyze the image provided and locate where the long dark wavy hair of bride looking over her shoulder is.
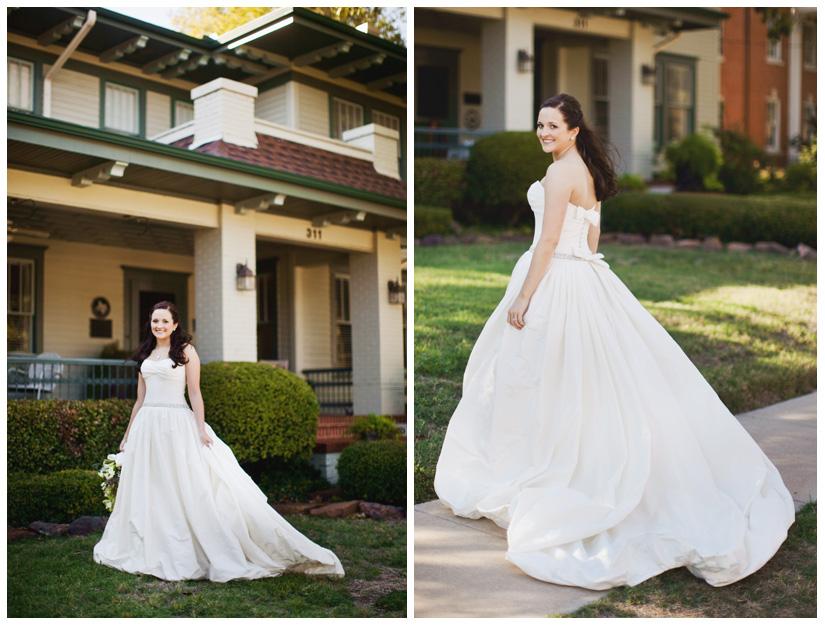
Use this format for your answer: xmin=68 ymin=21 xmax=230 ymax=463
xmin=539 ymin=93 xmax=619 ymax=202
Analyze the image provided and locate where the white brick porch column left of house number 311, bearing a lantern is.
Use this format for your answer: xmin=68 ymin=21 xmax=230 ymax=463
xmin=195 ymin=204 xmax=258 ymax=361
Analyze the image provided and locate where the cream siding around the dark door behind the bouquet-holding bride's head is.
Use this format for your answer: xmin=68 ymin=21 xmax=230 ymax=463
xmin=40 ymin=240 xmax=194 ymax=358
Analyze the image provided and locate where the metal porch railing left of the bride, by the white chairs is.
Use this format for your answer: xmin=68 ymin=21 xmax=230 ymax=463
xmin=6 ymin=355 xmax=137 ymax=400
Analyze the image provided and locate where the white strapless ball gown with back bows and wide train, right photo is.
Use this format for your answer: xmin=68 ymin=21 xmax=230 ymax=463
xmin=435 ymin=178 xmax=794 ymax=590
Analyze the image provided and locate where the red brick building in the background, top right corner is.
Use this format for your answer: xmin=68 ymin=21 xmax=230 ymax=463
xmin=719 ymin=7 xmax=816 ymax=164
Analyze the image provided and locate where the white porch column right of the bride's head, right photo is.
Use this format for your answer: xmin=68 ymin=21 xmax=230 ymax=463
xmin=608 ymin=22 xmax=656 ymax=178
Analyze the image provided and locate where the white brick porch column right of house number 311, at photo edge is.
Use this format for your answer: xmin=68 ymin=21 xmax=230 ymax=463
xmin=349 ymin=232 xmax=405 ymax=415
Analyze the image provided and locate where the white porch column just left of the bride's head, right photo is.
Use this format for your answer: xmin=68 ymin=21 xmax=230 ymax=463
xmin=481 ymin=7 xmax=536 ymax=130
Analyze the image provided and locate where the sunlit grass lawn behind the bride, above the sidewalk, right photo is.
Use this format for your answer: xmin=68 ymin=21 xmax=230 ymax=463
xmin=414 ymin=242 xmax=816 ymax=502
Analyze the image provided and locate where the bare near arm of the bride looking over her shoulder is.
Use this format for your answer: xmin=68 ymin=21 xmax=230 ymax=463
xmin=507 ymin=163 xmax=573 ymax=329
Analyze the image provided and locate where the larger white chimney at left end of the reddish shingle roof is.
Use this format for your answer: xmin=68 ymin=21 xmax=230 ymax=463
xmin=189 ymin=78 xmax=258 ymax=150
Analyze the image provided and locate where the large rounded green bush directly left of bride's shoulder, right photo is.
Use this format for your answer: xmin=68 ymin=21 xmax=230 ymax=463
xmin=460 ymin=131 xmax=552 ymax=225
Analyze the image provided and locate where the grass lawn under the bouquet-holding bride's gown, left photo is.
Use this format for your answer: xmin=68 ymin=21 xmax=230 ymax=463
xmin=7 ymin=516 xmax=407 ymax=618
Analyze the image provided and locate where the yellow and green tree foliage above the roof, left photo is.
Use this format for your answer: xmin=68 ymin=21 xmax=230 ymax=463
xmin=171 ymin=7 xmax=407 ymax=46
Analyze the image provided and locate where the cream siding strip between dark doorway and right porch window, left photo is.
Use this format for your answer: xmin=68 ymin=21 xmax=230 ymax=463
xmin=294 ymin=265 xmax=332 ymax=373
